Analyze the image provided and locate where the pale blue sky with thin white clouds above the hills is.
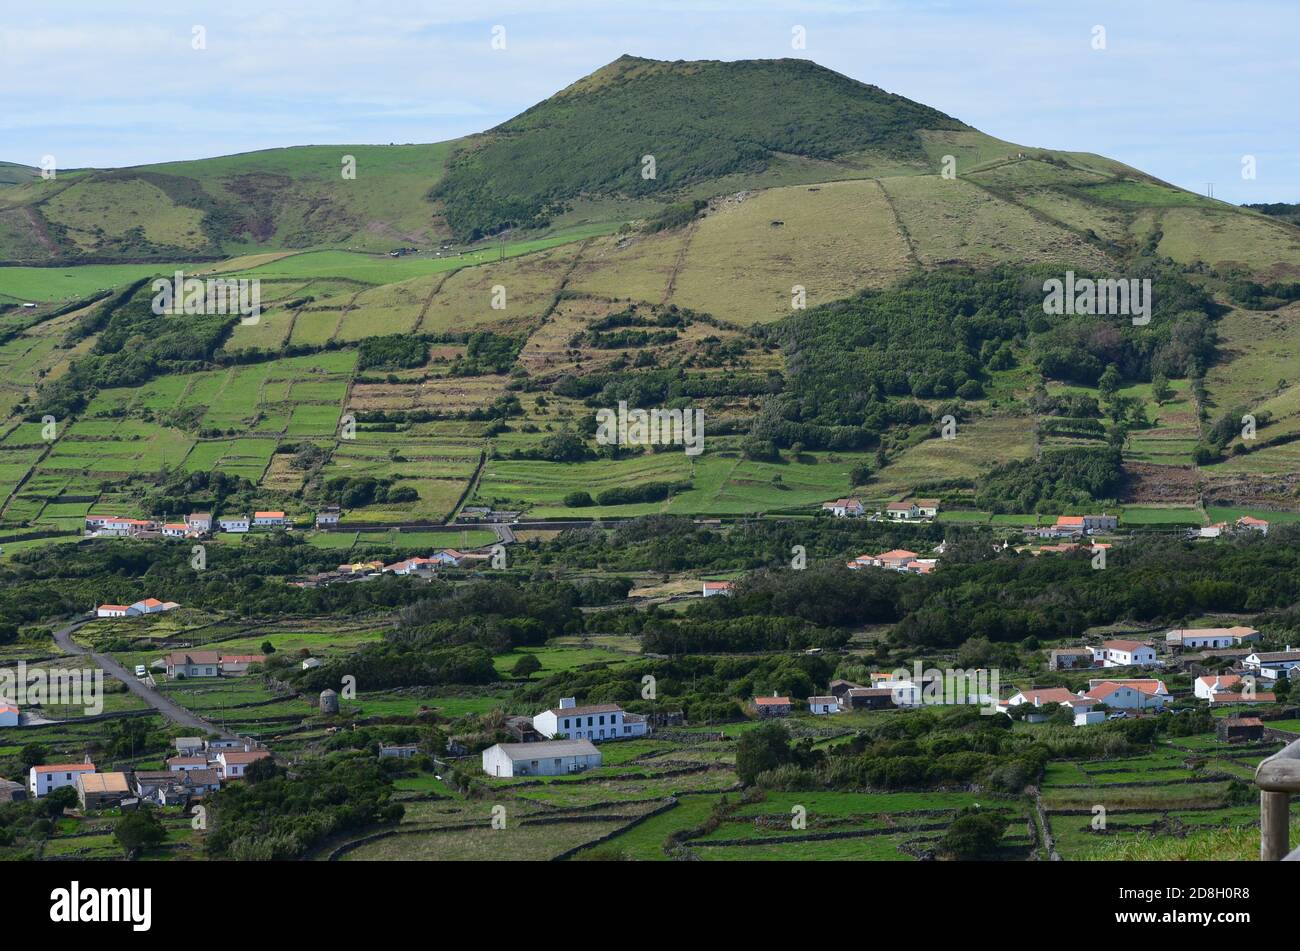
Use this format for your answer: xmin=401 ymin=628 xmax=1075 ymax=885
xmin=0 ymin=0 xmax=1300 ymax=203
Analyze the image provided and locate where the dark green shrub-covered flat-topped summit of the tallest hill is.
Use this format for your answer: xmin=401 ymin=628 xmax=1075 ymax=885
xmin=433 ymin=56 xmax=969 ymax=238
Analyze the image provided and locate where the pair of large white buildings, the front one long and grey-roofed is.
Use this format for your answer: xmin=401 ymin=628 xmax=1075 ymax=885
xmin=482 ymin=696 xmax=650 ymax=777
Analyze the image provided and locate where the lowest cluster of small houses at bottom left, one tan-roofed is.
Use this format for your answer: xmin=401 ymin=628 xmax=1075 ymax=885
xmin=26 ymin=737 xmax=270 ymax=811
